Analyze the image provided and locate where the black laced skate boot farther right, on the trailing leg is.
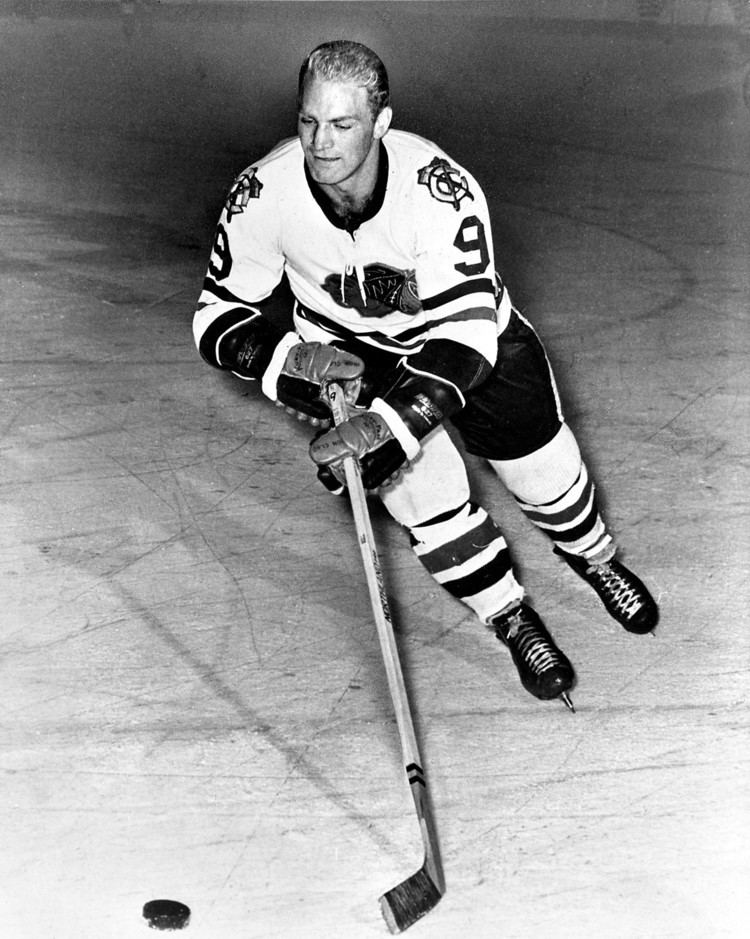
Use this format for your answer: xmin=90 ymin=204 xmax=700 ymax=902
xmin=555 ymin=548 xmax=659 ymax=634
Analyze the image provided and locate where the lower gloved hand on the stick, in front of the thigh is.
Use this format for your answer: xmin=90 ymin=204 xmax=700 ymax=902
xmin=310 ymin=411 xmax=406 ymax=489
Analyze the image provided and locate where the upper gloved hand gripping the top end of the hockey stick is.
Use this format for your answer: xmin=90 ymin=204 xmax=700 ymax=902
xmin=276 ymin=342 xmax=365 ymax=427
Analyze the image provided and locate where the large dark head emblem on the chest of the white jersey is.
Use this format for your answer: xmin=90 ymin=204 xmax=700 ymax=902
xmin=322 ymin=264 xmax=422 ymax=317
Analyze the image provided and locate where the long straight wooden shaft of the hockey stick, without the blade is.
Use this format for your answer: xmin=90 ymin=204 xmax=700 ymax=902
xmin=328 ymin=383 xmax=445 ymax=893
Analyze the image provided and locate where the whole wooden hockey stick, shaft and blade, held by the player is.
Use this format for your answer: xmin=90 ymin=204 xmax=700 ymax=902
xmin=328 ymin=383 xmax=445 ymax=933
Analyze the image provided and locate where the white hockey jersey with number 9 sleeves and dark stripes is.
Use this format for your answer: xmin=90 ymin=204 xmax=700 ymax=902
xmin=194 ymin=130 xmax=510 ymax=390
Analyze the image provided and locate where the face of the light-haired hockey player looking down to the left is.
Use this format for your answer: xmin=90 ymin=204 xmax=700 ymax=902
xmin=297 ymin=78 xmax=390 ymax=188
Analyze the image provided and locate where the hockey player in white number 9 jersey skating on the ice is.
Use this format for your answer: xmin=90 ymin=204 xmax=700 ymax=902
xmin=194 ymin=41 xmax=658 ymax=701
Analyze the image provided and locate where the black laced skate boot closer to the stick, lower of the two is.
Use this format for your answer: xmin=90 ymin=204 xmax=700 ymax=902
xmin=489 ymin=603 xmax=575 ymax=711
